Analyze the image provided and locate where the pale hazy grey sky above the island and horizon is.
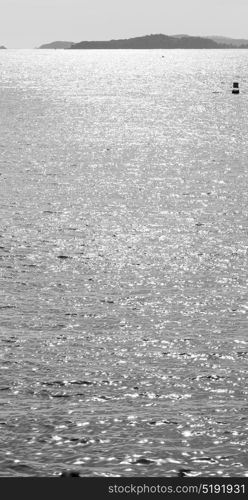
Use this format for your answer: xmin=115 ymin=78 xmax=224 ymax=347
xmin=0 ymin=0 xmax=248 ymax=48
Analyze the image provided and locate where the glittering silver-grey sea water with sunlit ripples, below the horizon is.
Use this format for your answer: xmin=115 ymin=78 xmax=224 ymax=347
xmin=0 ymin=50 xmax=248 ymax=476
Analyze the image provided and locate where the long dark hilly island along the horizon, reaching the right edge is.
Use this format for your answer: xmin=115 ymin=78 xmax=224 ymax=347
xmin=37 ymin=34 xmax=248 ymax=50
